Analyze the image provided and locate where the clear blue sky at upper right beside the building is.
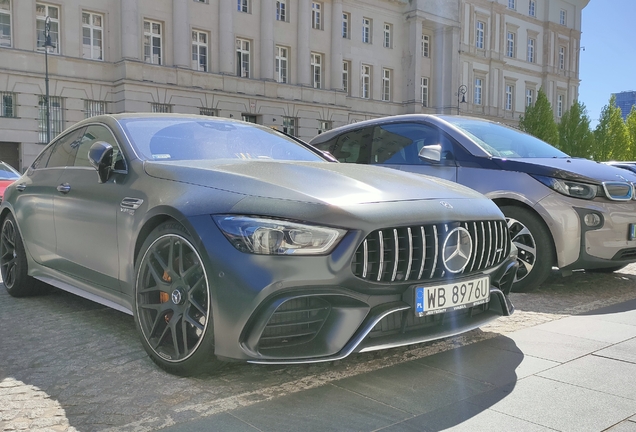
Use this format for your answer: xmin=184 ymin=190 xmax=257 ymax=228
xmin=579 ymin=0 xmax=636 ymax=128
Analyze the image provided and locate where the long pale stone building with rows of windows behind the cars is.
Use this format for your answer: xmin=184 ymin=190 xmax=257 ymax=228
xmin=0 ymin=0 xmax=589 ymax=169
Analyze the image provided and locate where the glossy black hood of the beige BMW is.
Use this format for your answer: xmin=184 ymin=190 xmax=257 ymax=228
xmin=493 ymin=158 xmax=636 ymax=183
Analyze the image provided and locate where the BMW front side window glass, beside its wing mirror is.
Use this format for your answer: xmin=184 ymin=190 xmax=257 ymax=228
xmin=371 ymin=123 xmax=454 ymax=165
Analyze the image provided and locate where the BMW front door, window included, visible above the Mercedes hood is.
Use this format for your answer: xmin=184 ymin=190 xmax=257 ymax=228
xmin=370 ymin=122 xmax=457 ymax=182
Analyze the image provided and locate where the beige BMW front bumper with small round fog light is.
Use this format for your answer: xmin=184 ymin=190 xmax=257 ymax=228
xmin=535 ymin=193 xmax=636 ymax=270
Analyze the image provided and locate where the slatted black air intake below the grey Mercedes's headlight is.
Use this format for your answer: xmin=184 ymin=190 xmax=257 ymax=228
xmin=258 ymin=297 xmax=331 ymax=351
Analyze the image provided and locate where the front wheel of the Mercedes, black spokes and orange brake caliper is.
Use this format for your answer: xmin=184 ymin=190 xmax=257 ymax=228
xmin=134 ymin=222 xmax=222 ymax=376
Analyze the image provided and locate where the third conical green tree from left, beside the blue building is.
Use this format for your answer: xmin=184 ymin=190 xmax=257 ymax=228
xmin=592 ymin=95 xmax=631 ymax=161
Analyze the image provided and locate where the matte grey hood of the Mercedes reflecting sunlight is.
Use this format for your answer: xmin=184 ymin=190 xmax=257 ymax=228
xmin=145 ymin=160 xmax=484 ymax=205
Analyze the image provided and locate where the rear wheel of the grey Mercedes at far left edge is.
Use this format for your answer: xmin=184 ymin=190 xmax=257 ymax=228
xmin=0 ymin=213 xmax=50 ymax=297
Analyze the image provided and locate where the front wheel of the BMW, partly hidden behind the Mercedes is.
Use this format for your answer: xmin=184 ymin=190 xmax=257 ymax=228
xmin=501 ymin=206 xmax=555 ymax=292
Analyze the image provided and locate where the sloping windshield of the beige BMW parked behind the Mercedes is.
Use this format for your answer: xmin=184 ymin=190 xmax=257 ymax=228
xmin=444 ymin=117 xmax=569 ymax=158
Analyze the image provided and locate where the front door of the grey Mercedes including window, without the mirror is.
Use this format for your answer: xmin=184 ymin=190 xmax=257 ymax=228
xmin=54 ymin=124 xmax=126 ymax=291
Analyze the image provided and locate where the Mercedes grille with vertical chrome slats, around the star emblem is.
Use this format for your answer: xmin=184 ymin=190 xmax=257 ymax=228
xmin=351 ymin=220 xmax=510 ymax=282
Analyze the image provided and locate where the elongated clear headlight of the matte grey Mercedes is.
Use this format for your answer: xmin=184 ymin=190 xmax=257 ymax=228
xmin=212 ymin=215 xmax=347 ymax=255
